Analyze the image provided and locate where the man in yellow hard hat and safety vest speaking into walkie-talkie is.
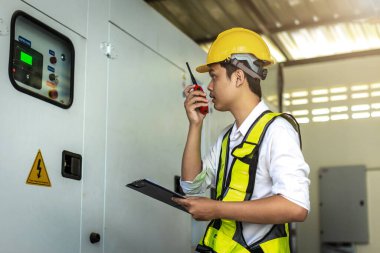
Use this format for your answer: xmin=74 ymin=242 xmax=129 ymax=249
xmin=173 ymin=28 xmax=310 ymax=253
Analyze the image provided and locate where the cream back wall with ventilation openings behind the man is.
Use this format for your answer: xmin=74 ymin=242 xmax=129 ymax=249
xmin=284 ymin=56 xmax=380 ymax=253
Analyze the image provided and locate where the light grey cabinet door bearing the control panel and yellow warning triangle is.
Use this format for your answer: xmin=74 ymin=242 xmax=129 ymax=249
xmin=0 ymin=1 xmax=85 ymax=253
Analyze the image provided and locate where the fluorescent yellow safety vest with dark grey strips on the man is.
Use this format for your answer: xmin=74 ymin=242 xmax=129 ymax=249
xmin=196 ymin=111 xmax=299 ymax=253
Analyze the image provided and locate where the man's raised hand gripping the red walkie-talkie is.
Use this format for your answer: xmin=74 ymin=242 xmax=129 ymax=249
xmin=183 ymin=85 xmax=208 ymax=124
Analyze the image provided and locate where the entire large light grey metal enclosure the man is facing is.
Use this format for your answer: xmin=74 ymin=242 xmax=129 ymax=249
xmin=0 ymin=0 xmax=211 ymax=253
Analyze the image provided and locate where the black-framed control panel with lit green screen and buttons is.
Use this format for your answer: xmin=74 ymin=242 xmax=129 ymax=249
xmin=9 ymin=11 xmax=75 ymax=108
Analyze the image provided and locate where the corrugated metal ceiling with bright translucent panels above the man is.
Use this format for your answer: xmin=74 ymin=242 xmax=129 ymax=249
xmin=145 ymin=0 xmax=380 ymax=63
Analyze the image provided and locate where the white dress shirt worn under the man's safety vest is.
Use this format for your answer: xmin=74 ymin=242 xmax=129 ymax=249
xmin=181 ymin=101 xmax=310 ymax=245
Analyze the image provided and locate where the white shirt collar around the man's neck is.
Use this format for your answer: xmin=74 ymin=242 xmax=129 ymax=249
xmin=230 ymin=100 xmax=269 ymax=140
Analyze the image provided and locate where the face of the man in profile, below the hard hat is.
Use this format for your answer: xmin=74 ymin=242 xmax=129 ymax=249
xmin=207 ymin=63 xmax=237 ymax=111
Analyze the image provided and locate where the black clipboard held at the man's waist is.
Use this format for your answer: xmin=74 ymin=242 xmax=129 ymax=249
xmin=126 ymin=179 xmax=188 ymax=213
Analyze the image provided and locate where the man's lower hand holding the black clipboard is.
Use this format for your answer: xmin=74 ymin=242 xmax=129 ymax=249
xmin=172 ymin=197 xmax=220 ymax=221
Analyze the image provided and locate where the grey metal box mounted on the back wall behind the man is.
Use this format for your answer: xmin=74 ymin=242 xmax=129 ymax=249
xmin=319 ymin=166 xmax=369 ymax=243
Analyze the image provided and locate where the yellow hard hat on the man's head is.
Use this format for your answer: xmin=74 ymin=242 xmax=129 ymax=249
xmin=196 ymin=28 xmax=273 ymax=73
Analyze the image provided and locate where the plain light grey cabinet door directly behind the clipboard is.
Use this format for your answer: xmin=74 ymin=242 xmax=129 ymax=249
xmin=104 ymin=22 xmax=191 ymax=253
